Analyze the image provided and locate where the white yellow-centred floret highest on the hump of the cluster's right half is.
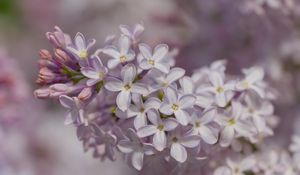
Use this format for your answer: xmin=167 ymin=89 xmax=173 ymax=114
xmin=197 ymin=71 xmax=234 ymax=107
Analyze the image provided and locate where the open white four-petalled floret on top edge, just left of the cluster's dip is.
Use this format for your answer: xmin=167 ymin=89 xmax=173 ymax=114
xmin=139 ymin=44 xmax=170 ymax=74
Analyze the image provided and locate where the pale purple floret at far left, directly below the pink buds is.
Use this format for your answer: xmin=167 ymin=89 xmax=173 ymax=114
xmin=59 ymin=95 xmax=86 ymax=125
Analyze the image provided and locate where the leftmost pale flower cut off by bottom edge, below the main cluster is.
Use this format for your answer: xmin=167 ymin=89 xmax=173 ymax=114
xmin=214 ymin=156 xmax=256 ymax=175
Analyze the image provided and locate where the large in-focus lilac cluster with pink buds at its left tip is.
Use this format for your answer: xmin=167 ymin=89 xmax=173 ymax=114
xmin=35 ymin=24 xmax=276 ymax=170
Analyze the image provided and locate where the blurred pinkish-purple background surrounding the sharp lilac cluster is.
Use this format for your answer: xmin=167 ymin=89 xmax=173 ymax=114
xmin=0 ymin=0 xmax=300 ymax=175
